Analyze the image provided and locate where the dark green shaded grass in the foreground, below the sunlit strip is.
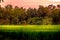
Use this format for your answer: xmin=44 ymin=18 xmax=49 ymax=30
xmin=0 ymin=30 xmax=60 ymax=40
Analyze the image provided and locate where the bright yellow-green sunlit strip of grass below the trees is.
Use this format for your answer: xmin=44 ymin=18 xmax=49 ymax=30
xmin=0 ymin=25 xmax=60 ymax=32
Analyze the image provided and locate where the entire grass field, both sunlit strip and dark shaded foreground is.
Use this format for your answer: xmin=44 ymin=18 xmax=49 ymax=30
xmin=0 ymin=25 xmax=60 ymax=40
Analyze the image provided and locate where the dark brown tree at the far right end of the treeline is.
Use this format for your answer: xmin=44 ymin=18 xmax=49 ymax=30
xmin=52 ymin=9 xmax=60 ymax=24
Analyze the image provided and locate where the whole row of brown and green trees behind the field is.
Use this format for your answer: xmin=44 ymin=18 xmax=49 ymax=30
xmin=0 ymin=5 xmax=60 ymax=25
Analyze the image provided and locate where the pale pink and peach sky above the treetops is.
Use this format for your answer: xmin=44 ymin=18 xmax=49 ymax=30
xmin=0 ymin=0 xmax=60 ymax=8
